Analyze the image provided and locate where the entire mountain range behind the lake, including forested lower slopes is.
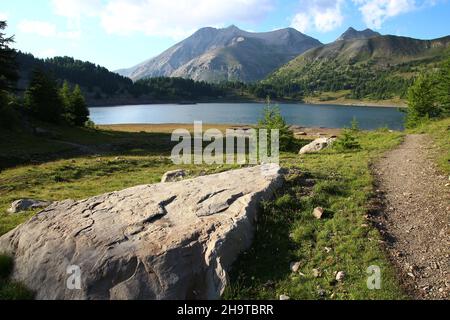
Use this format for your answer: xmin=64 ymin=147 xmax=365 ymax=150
xmin=17 ymin=26 xmax=450 ymax=105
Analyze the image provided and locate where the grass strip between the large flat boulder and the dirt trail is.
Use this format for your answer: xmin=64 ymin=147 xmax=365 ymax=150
xmin=225 ymin=131 xmax=405 ymax=299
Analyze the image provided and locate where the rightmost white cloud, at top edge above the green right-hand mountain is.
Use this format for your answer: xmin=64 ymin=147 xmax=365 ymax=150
xmin=354 ymin=0 xmax=418 ymax=29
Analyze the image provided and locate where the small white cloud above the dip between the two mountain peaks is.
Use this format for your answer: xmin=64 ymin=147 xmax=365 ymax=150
xmin=291 ymin=0 xmax=345 ymax=32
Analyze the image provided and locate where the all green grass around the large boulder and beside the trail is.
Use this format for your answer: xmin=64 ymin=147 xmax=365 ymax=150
xmin=0 ymin=120 xmax=450 ymax=299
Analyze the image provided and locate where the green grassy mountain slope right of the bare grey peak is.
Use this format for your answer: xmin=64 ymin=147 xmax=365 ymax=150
xmin=262 ymin=35 xmax=450 ymax=100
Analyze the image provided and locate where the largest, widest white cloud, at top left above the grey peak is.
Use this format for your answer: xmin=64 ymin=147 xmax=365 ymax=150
xmin=52 ymin=0 xmax=275 ymax=38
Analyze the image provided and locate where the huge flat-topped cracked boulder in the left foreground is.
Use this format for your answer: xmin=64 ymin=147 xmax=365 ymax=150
xmin=0 ymin=165 xmax=283 ymax=300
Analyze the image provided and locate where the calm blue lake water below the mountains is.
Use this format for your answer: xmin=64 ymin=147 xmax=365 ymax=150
xmin=90 ymin=103 xmax=404 ymax=130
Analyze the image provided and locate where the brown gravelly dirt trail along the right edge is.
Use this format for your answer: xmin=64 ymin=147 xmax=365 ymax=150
xmin=374 ymin=135 xmax=450 ymax=299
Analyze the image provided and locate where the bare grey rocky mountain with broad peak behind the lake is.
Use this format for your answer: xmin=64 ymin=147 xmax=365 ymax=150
xmin=117 ymin=26 xmax=322 ymax=82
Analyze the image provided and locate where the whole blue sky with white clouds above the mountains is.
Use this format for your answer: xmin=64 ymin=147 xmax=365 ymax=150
xmin=0 ymin=0 xmax=450 ymax=70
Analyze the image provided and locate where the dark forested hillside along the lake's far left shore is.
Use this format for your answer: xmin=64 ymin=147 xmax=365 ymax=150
xmin=16 ymin=52 xmax=232 ymax=106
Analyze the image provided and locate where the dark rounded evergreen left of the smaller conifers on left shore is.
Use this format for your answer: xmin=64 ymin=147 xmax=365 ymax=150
xmin=25 ymin=70 xmax=64 ymax=123
